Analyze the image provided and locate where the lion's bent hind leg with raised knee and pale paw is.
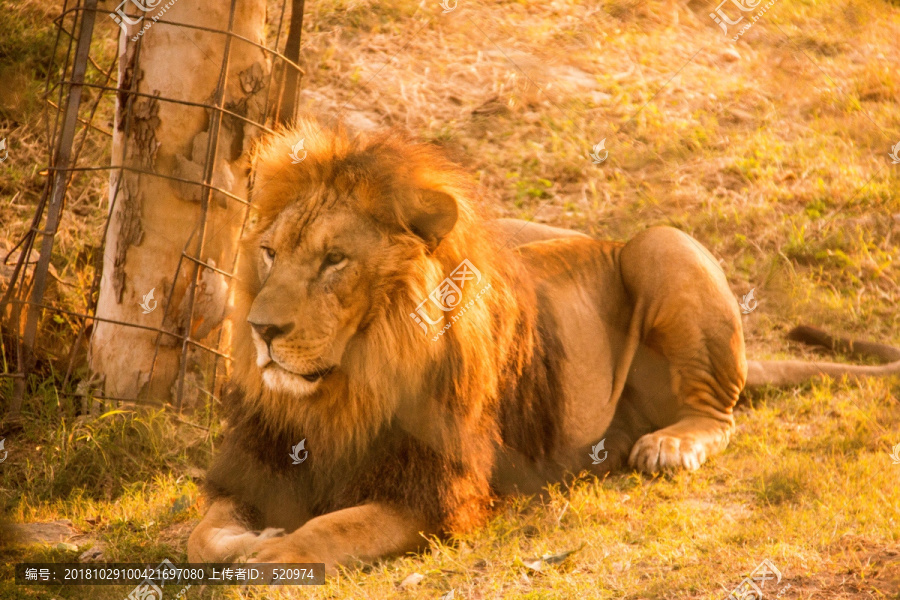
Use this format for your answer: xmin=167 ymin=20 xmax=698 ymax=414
xmin=621 ymin=227 xmax=747 ymax=473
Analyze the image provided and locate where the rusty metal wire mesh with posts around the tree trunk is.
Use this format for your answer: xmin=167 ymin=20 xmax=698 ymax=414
xmin=0 ymin=0 xmax=303 ymax=422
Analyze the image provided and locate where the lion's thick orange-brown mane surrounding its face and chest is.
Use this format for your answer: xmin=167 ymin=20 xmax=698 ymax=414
xmin=210 ymin=120 xmax=561 ymax=532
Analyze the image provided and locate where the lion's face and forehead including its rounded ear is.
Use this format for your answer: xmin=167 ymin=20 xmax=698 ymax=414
xmin=247 ymin=172 xmax=456 ymax=395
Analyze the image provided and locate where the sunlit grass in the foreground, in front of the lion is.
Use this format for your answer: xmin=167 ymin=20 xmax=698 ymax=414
xmin=0 ymin=380 xmax=900 ymax=599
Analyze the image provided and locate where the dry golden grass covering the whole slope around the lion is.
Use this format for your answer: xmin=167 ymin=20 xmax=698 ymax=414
xmin=0 ymin=0 xmax=900 ymax=599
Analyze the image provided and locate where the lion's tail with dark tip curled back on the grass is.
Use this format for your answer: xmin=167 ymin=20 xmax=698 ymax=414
xmin=746 ymin=325 xmax=900 ymax=387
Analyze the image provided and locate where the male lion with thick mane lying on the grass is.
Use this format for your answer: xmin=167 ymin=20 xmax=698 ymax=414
xmin=188 ymin=121 xmax=900 ymax=571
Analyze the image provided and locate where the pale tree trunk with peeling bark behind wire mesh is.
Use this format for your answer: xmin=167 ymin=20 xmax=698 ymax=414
xmin=90 ymin=0 xmax=271 ymax=401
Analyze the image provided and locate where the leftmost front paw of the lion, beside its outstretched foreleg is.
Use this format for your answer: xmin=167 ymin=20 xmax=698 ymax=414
xmin=188 ymin=499 xmax=284 ymax=563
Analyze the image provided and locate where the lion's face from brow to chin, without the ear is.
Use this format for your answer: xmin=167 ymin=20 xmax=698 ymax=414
xmin=247 ymin=203 xmax=387 ymax=395
